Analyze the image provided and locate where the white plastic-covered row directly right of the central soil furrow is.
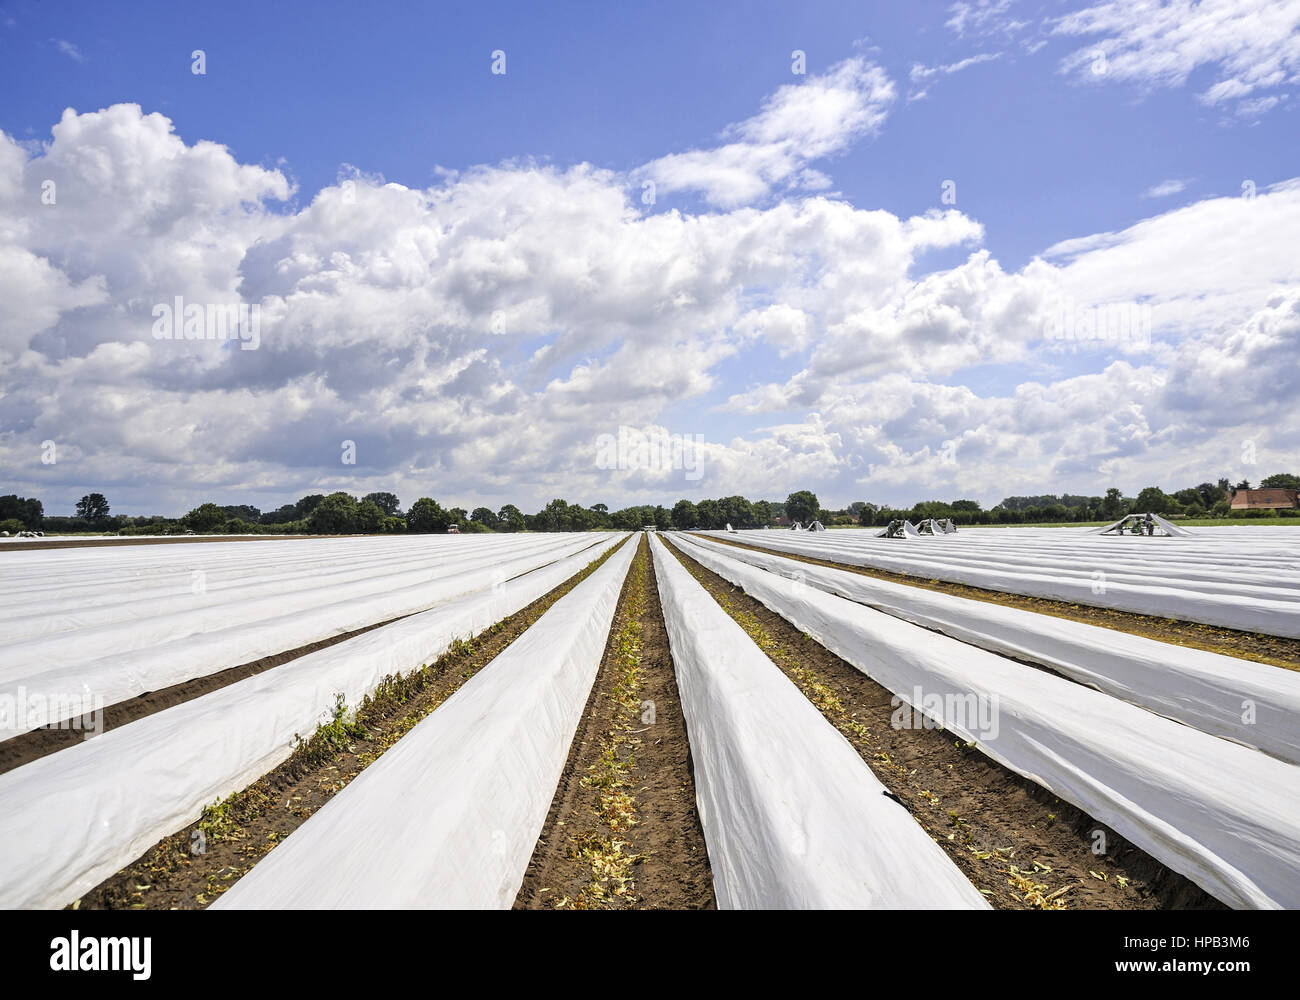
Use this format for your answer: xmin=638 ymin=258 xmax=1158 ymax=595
xmin=653 ymin=542 xmax=988 ymax=909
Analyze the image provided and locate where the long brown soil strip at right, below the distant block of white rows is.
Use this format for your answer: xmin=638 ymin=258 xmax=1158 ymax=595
xmin=706 ymin=534 xmax=1300 ymax=670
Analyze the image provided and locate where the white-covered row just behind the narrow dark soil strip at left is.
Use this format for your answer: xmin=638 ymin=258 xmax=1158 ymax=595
xmin=0 ymin=534 xmax=593 ymax=740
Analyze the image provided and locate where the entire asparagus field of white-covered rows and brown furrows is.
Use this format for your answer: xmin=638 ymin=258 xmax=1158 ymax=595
xmin=0 ymin=527 xmax=1300 ymax=910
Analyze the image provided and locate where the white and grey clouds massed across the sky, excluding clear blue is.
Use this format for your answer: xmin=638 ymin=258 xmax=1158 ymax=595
xmin=0 ymin=0 xmax=1300 ymax=514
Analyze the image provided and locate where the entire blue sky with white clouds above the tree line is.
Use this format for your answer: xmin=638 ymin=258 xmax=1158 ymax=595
xmin=0 ymin=0 xmax=1300 ymax=512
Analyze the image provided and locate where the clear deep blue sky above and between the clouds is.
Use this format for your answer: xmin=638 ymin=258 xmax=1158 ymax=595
xmin=0 ymin=3 xmax=1296 ymax=267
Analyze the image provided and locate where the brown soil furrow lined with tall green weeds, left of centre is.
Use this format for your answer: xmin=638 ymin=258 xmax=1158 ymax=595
xmin=73 ymin=540 xmax=615 ymax=909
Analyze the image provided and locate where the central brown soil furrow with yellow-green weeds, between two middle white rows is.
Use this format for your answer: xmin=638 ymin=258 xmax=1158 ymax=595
xmin=515 ymin=537 xmax=716 ymax=909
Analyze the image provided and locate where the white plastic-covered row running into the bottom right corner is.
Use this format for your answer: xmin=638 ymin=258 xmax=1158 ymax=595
xmin=673 ymin=538 xmax=1300 ymax=909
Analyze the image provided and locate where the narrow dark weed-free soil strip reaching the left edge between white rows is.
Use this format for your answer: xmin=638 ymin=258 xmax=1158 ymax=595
xmin=0 ymin=615 xmax=406 ymax=774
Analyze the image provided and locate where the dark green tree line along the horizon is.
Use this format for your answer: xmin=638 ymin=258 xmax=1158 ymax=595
xmin=0 ymin=473 xmax=1300 ymax=534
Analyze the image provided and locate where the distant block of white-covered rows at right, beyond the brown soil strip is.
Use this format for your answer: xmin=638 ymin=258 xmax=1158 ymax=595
xmin=712 ymin=527 xmax=1300 ymax=638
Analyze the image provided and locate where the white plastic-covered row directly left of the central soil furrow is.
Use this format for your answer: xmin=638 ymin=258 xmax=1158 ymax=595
xmin=213 ymin=540 xmax=637 ymax=909
